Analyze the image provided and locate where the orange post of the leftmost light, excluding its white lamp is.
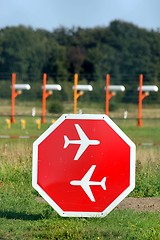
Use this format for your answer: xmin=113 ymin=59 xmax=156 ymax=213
xmin=11 ymin=73 xmax=21 ymax=123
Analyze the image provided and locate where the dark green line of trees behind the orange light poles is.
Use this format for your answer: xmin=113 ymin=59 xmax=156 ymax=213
xmin=0 ymin=21 xmax=160 ymax=104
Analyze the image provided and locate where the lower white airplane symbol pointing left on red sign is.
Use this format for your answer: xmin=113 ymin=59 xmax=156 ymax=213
xmin=70 ymin=165 xmax=106 ymax=202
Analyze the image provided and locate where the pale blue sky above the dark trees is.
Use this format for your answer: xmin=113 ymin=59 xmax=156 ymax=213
xmin=0 ymin=0 xmax=160 ymax=31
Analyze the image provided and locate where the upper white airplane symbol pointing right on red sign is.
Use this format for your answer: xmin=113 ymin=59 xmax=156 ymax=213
xmin=64 ymin=124 xmax=100 ymax=160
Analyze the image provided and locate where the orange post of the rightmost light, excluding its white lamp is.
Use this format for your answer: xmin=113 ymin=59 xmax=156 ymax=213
xmin=137 ymin=74 xmax=149 ymax=127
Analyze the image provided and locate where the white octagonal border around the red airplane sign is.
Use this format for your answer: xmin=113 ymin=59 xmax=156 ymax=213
xmin=32 ymin=114 xmax=136 ymax=217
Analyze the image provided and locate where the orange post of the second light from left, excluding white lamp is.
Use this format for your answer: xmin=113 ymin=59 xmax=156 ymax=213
xmin=41 ymin=73 xmax=52 ymax=123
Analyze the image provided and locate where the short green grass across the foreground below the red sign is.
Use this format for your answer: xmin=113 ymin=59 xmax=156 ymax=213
xmin=0 ymin=210 xmax=160 ymax=240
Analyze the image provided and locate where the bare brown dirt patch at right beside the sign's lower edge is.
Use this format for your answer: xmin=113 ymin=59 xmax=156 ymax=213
xmin=116 ymin=197 xmax=160 ymax=212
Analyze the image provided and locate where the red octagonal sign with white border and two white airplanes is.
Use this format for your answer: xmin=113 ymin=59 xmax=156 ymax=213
xmin=32 ymin=114 xmax=136 ymax=217
